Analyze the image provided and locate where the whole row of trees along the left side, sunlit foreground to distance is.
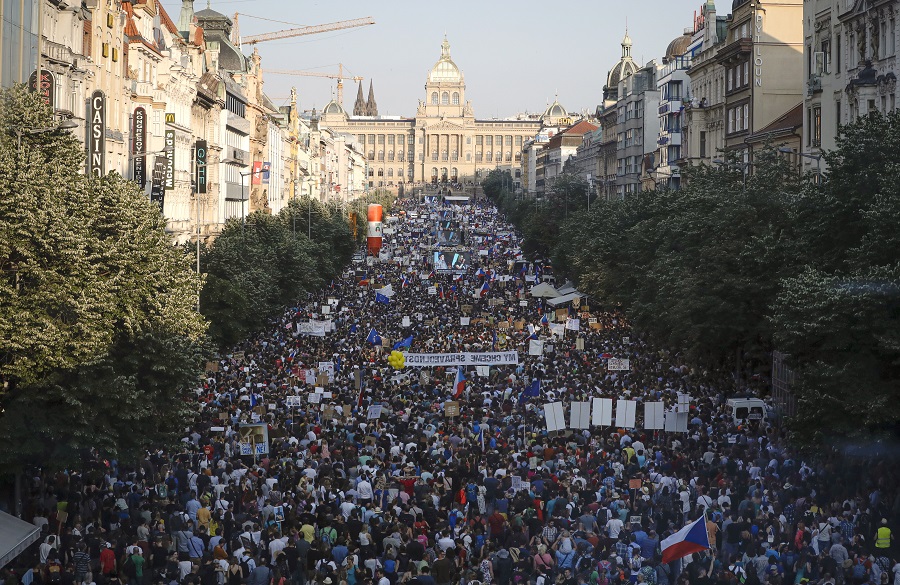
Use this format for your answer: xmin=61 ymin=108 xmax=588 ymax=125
xmin=0 ymin=86 xmax=365 ymax=471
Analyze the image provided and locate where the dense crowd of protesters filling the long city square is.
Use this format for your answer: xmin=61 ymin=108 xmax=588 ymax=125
xmin=3 ymin=200 xmax=900 ymax=585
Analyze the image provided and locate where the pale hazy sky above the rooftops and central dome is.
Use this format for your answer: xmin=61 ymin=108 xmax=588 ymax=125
xmin=162 ymin=0 xmax=712 ymax=118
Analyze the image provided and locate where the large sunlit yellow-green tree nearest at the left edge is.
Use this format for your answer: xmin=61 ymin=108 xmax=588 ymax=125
xmin=0 ymin=87 xmax=206 ymax=469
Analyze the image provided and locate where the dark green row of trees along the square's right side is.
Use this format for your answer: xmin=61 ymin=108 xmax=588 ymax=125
xmin=486 ymin=113 xmax=900 ymax=444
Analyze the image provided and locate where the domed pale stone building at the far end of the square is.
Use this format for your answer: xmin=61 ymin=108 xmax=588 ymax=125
xmin=322 ymin=38 xmax=552 ymax=187
